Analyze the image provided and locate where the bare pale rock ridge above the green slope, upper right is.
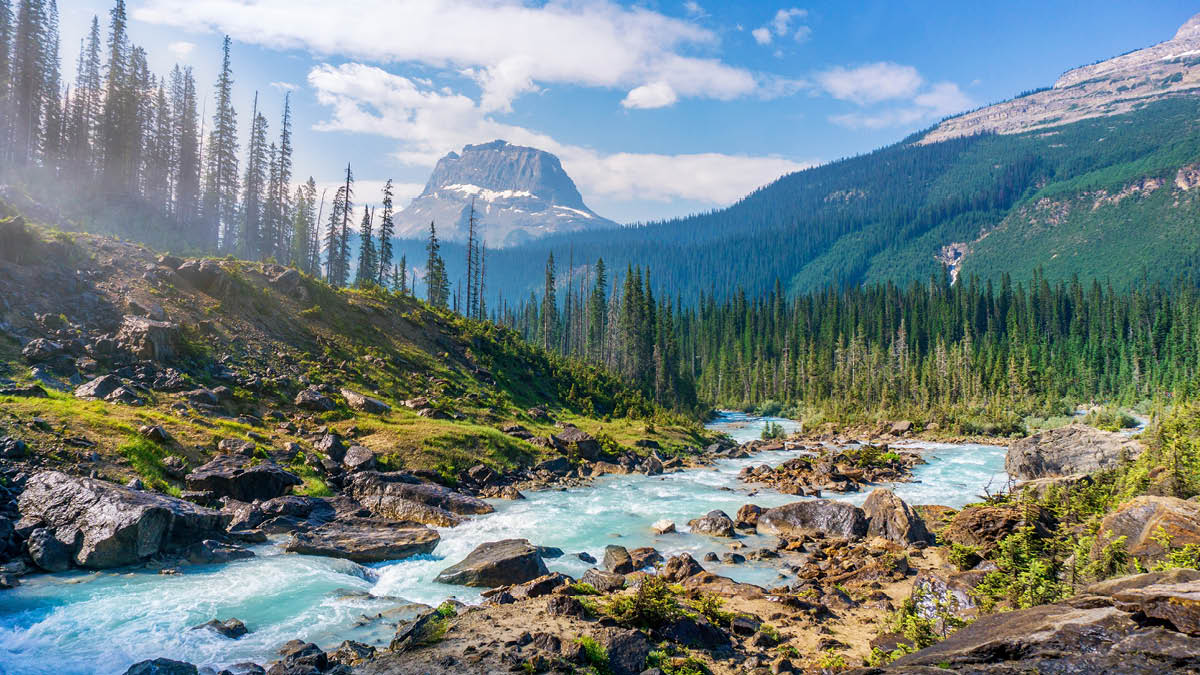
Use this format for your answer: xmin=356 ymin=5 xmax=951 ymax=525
xmin=920 ymin=14 xmax=1200 ymax=144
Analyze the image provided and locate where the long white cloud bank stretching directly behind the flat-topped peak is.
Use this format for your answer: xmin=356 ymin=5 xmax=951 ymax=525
xmin=308 ymin=64 xmax=811 ymax=204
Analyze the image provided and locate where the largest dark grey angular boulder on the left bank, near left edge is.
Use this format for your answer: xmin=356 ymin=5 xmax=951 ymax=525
xmin=17 ymin=471 xmax=228 ymax=569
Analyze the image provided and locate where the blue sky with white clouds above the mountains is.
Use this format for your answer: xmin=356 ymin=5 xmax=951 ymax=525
xmin=59 ymin=0 xmax=1200 ymax=222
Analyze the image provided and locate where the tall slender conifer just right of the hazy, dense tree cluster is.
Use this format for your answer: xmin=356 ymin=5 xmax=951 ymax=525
xmin=200 ymin=35 xmax=239 ymax=251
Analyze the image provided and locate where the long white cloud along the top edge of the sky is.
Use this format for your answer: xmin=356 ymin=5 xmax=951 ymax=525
xmin=133 ymin=0 xmax=768 ymax=112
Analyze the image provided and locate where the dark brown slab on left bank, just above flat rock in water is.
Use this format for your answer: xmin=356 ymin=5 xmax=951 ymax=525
xmin=346 ymin=471 xmax=496 ymax=527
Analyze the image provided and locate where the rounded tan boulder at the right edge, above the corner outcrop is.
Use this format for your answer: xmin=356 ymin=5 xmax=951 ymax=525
xmin=1093 ymin=496 xmax=1200 ymax=565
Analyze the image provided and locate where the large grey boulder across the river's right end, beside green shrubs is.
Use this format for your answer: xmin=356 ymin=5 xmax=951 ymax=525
xmin=1004 ymin=424 xmax=1142 ymax=480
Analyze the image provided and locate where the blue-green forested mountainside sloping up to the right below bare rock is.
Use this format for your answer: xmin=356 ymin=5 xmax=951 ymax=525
xmin=465 ymin=96 xmax=1200 ymax=304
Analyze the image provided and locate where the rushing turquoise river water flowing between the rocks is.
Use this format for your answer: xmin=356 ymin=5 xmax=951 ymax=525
xmin=0 ymin=412 xmax=1007 ymax=675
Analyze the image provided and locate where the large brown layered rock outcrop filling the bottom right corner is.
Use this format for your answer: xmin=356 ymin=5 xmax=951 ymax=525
xmin=883 ymin=571 xmax=1200 ymax=675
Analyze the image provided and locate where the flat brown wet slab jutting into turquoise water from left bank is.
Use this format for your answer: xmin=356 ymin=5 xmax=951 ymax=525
xmin=284 ymin=518 xmax=442 ymax=563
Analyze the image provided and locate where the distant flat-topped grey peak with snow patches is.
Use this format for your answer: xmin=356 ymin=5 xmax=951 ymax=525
xmin=396 ymin=141 xmax=617 ymax=247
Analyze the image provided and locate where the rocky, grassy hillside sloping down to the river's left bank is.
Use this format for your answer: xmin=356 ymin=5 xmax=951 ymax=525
xmin=0 ymin=211 xmax=708 ymax=492
